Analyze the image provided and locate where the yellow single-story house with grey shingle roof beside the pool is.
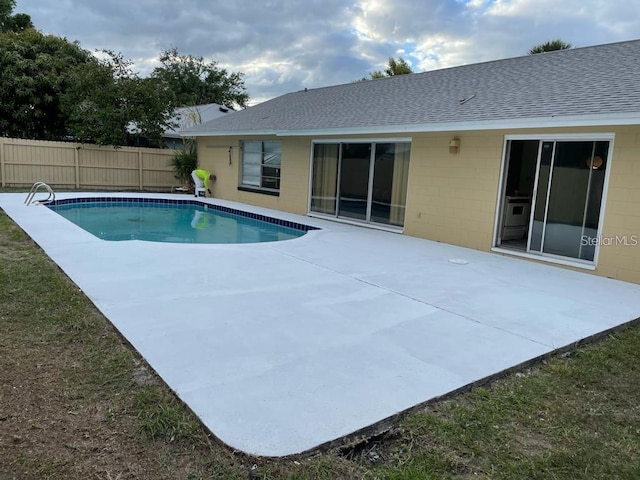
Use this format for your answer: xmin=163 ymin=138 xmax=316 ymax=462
xmin=188 ymin=40 xmax=640 ymax=283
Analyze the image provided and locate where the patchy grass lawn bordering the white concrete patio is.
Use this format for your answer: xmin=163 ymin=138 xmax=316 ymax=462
xmin=0 ymin=203 xmax=640 ymax=480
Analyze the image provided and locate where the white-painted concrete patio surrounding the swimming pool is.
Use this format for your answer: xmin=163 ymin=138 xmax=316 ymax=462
xmin=0 ymin=193 xmax=640 ymax=456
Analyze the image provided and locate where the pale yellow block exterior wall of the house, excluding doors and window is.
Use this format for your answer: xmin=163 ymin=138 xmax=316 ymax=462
xmin=199 ymin=127 xmax=640 ymax=283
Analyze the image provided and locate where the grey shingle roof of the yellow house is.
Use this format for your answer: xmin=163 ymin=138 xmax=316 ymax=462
xmin=190 ymin=40 xmax=640 ymax=135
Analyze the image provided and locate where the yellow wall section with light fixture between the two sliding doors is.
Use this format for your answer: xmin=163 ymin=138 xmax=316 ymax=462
xmin=405 ymin=132 xmax=504 ymax=250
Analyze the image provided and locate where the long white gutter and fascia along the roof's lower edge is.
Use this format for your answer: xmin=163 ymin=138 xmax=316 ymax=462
xmin=181 ymin=112 xmax=640 ymax=137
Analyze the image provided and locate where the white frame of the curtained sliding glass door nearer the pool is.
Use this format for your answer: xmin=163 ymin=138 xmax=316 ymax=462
xmin=307 ymin=137 xmax=413 ymax=232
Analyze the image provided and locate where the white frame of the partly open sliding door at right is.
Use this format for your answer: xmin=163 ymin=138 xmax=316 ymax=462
xmin=491 ymin=133 xmax=615 ymax=270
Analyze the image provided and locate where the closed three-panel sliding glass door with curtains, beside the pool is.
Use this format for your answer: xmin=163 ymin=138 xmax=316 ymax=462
xmin=310 ymin=142 xmax=411 ymax=227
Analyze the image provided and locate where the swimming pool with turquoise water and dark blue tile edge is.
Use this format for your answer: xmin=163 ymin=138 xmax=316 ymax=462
xmin=47 ymin=197 xmax=316 ymax=243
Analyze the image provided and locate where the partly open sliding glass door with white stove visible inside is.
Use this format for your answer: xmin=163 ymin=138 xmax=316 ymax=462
xmin=497 ymin=140 xmax=610 ymax=262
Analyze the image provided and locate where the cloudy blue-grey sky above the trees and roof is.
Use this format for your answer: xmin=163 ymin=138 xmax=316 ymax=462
xmin=14 ymin=0 xmax=640 ymax=104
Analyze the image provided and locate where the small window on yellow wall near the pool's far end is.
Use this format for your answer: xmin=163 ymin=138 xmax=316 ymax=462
xmin=241 ymin=141 xmax=282 ymax=190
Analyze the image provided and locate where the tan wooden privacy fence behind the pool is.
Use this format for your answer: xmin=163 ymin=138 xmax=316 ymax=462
xmin=0 ymin=137 xmax=180 ymax=191
